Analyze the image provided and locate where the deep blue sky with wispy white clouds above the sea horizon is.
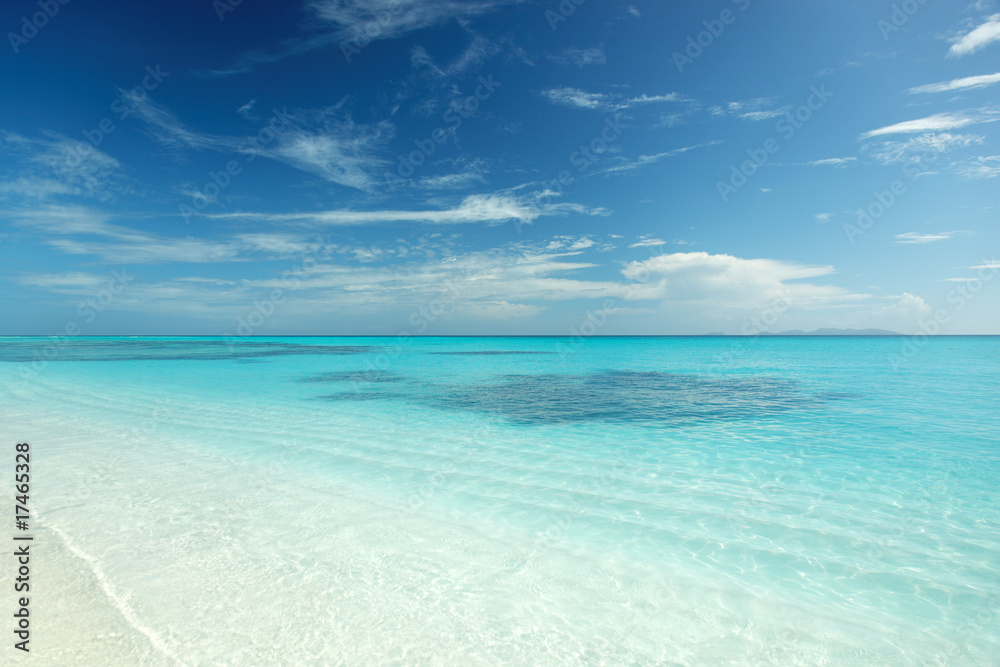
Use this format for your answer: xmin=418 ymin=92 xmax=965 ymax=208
xmin=0 ymin=0 xmax=1000 ymax=336
